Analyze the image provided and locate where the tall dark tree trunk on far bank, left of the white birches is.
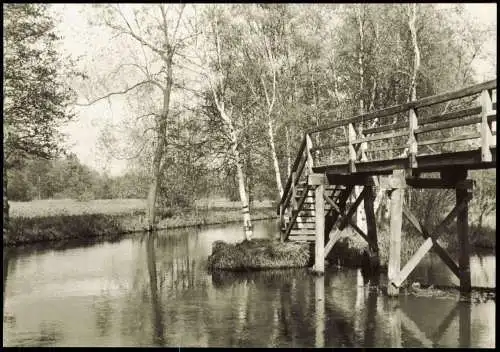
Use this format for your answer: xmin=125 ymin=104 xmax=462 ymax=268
xmin=148 ymin=56 xmax=172 ymax=231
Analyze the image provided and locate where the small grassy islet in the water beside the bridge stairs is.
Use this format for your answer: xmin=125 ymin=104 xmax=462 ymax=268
xmin=208 ymin=239 xmax=311 ymax=271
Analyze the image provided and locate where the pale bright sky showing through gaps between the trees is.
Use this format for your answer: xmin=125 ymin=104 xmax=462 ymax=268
xmin=52 ymin=3 xmax=497 ymax=176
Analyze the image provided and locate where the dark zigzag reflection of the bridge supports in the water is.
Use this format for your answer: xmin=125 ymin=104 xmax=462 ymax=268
xmin=314 ymin=273 xmax=472 ymax=348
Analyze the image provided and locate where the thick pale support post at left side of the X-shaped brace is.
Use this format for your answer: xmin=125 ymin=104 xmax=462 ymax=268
xmin=387 ymin=170 xmax=404 ymax=296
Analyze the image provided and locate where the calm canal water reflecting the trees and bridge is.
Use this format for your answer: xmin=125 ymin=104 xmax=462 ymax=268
xmin=3 ymin=221 xmax=496 ymax=347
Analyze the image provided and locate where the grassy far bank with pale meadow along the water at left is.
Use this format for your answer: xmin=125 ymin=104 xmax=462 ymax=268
xmin=3 ymin=199 xmax=275 ymax=246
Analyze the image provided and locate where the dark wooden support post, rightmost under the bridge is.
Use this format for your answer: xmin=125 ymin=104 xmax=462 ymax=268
xmin=456 ymin=171 xmax=471 ymax=293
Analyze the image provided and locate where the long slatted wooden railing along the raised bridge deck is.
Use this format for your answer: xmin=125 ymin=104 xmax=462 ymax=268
xmin=301 ymin=79 xmax=496 ymax=172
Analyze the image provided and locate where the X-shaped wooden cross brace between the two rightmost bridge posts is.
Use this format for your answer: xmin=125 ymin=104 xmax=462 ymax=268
xmin=392 ymin=196 xmax=470 ymax=287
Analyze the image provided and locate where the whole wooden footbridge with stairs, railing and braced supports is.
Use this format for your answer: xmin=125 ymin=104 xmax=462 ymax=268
xmin=278 ymin=79 xmax=496 ymax=295
